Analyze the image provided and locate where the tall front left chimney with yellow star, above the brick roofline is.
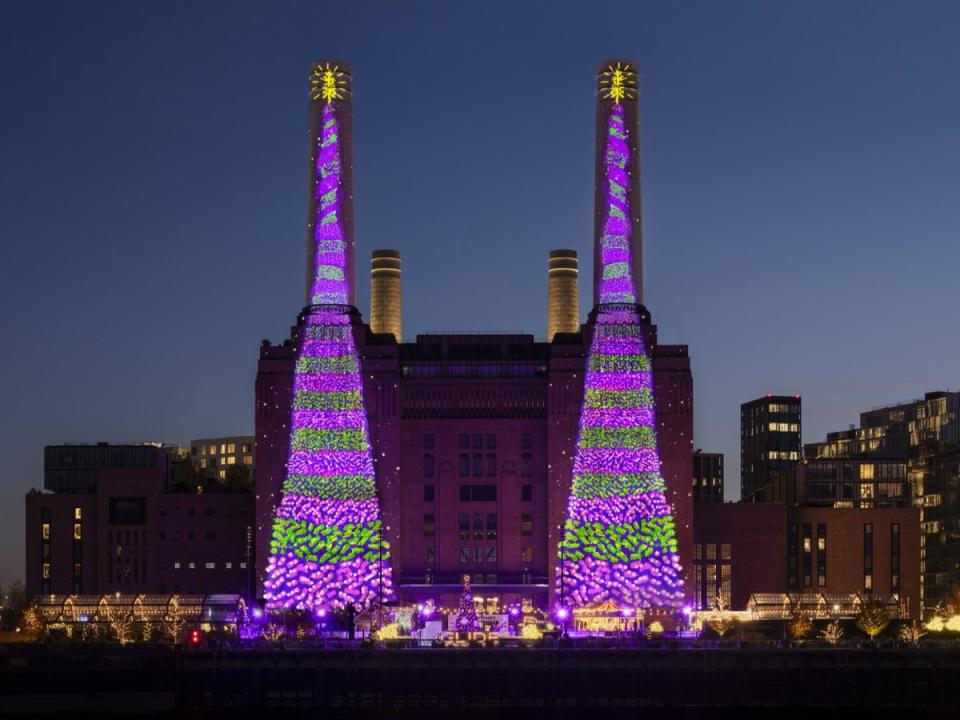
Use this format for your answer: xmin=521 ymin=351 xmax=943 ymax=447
xmin=306 ymin=60 xmax=357 ymax=306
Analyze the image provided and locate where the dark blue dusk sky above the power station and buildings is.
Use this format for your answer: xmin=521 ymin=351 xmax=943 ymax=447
xmin=0 ymin=0 xmax=960 ymax=582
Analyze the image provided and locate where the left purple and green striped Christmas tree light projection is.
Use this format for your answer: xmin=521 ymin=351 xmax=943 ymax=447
xmin=264 ymin=86 xmax=393 ymax=612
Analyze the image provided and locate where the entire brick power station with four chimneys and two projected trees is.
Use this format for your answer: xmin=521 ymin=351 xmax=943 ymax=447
xmin=256 ymin=60 xmax=693 ymax=608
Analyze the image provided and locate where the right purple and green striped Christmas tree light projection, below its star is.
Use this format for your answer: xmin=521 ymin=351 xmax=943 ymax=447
xmin=557 ymin=100 xmax=683 ymax=609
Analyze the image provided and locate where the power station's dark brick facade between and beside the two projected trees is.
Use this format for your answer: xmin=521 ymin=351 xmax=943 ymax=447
xmin=255 ymin=315 xmax=693 ymax=607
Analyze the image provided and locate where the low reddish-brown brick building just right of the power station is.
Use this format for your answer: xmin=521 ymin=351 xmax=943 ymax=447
xmin=693 ymin=502 xmax=921 ymax=617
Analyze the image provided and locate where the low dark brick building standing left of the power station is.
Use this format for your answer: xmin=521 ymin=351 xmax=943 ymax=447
xmin=24 ymin=444 xmax=254 ymax=596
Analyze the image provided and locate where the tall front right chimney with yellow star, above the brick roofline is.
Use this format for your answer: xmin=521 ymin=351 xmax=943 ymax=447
xmin=593 ymin=58 xmax=643 ymax=306
